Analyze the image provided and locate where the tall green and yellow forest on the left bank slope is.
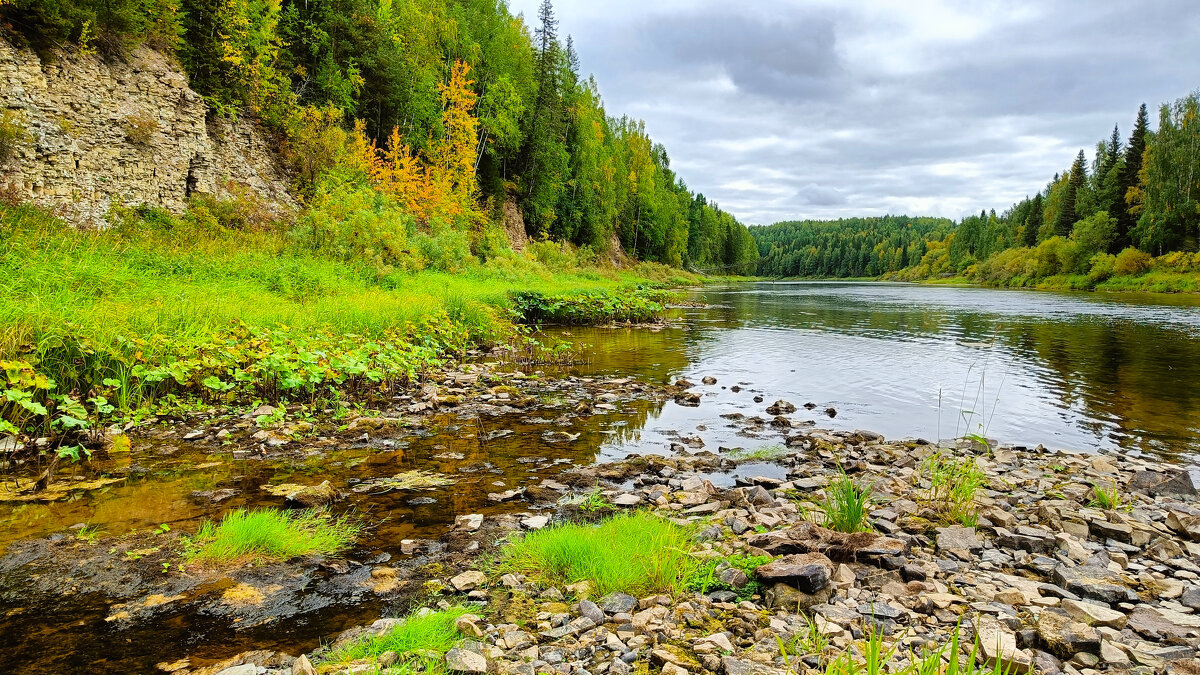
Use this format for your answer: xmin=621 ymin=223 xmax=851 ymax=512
xmin=0 ymin=0 xmax=757 ymax=274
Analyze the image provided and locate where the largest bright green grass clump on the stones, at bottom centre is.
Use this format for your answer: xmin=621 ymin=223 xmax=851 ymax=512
xmin=498 ymin=512 xmax=696 ymax=596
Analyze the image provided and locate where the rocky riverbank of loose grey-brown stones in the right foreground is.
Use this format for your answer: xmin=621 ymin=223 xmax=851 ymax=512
xmin=177 ymin=413 xmax=1200 ymax=675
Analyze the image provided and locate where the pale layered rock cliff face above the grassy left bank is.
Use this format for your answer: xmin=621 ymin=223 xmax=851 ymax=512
xmin=0 ymin=38 xmax=294 ymax=226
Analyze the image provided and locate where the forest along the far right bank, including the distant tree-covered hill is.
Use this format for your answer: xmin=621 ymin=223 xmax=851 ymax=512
xmin=750 ymin=92 xmax=1200 ymax=289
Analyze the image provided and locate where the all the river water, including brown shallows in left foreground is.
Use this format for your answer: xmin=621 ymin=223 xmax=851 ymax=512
xmin=0 ymin=282 xmax=1200 ymax=673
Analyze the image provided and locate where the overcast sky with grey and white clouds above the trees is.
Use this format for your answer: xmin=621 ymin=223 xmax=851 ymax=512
xmin=509 ymin=0 xmax=1200 ymax=225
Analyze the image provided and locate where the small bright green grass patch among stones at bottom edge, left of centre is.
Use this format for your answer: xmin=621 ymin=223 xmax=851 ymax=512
xmin=324 ymin=607 xmax=472 ymax=675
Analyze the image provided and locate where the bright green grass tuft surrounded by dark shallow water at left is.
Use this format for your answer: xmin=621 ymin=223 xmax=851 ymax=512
xmin=185 ymin=509 xmax=361 ymax=563
